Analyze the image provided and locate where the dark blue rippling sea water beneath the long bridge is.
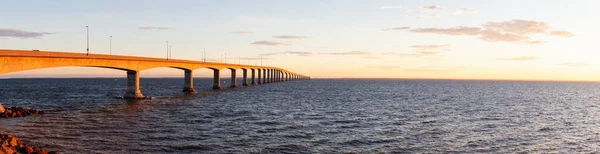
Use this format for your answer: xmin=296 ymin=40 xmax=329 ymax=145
xmin=0 ymin=78 xmax=600 ymax=153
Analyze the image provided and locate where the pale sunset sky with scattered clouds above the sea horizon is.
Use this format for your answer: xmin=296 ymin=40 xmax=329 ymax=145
xmin=0 ymin=0 xmax=600 ymax=81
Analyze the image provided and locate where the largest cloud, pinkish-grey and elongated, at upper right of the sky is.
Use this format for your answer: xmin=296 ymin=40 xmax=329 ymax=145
xmin=410 ymin=20 xmax=575 ymax=44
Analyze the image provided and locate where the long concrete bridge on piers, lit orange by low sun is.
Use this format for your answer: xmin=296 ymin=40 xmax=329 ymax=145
xmin=0 ymin=50 xmax=310 ymax=99
